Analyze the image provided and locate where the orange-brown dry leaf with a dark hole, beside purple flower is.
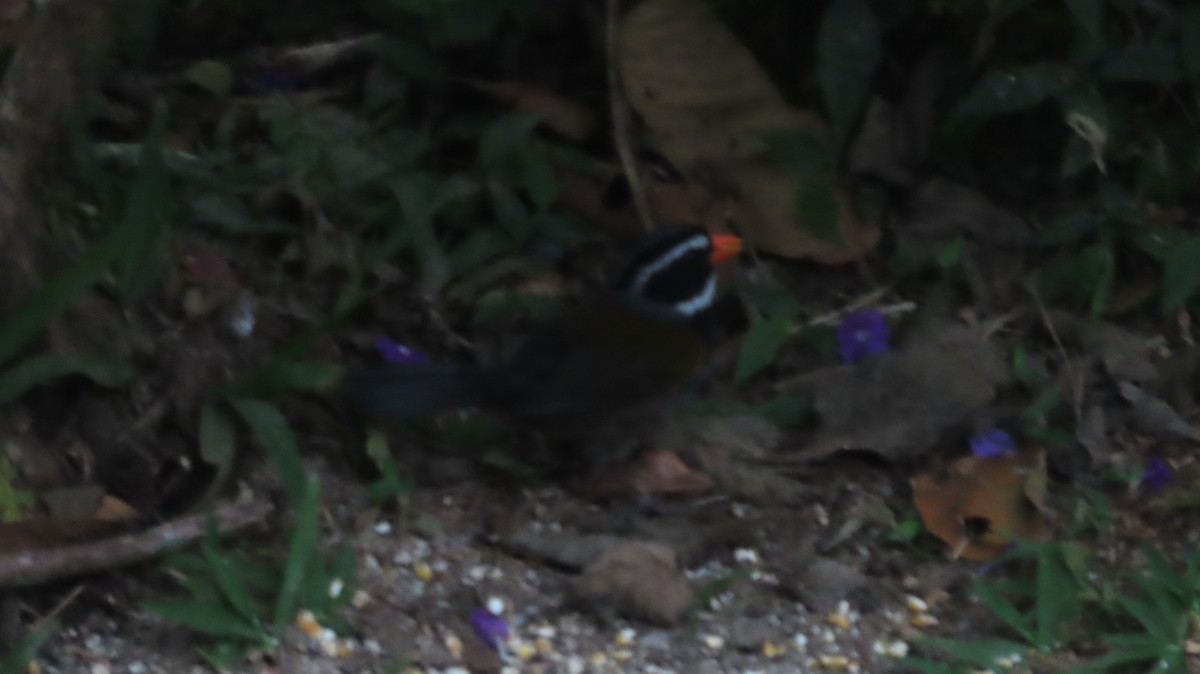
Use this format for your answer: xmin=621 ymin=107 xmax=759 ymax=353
xmin=912 ymin=450 xmax=1046 ymax=561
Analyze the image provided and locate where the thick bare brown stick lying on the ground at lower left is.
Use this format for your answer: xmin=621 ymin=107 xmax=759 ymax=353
xmin=0 ymin=501 xmax=274 ymax=588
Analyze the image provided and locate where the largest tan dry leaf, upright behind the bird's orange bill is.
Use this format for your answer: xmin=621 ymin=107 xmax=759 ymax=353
xmin=618 ymin=0 xmax=880 ymax=264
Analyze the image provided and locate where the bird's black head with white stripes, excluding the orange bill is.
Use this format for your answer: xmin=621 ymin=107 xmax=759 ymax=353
xmin=614 ymin=225 xmax=728 ymax=317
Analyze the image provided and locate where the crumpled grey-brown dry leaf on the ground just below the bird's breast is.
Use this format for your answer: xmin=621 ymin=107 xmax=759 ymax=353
xmin=655 ymin=415 xmax=805 ymax=503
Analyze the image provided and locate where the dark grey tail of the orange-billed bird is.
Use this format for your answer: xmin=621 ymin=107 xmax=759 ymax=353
xmin=347 ymin=363 xmax=487 ymax=420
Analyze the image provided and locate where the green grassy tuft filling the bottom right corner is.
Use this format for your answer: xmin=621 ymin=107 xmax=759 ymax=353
xmin=905 ymin=542 xmax=1200 ymax=674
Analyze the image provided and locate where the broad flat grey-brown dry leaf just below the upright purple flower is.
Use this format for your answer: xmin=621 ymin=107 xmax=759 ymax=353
xmin=796 ymin=324 xmax=1010 ymax=461
